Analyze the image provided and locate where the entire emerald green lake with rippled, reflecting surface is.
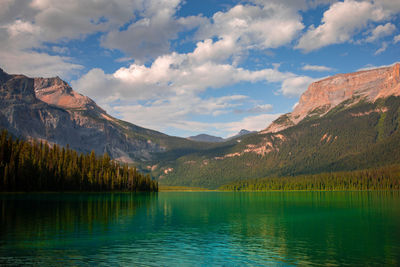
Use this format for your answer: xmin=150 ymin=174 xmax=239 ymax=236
xmin=0 ymin=192 xmax=400 ymax=266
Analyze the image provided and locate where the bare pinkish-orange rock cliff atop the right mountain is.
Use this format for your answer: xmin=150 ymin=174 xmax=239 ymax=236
xmin=262 ymin=63 xmax=400 ymax=133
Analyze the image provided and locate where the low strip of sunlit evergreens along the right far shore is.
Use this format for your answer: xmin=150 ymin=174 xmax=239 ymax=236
xmin=220 ymin=165 xmax=400 ymax=191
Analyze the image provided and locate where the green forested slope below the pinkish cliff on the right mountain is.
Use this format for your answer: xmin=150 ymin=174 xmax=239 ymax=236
xmin=156 ymin=97 xmax=400 ymax=188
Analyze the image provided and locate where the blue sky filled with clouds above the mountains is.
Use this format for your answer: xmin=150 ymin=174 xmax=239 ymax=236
xmin=0 ymin=0 xmax=400 ymax=137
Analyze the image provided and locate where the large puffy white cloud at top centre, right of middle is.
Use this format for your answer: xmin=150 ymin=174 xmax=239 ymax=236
xmin=197 ymin=2 xmax=304 ymax=49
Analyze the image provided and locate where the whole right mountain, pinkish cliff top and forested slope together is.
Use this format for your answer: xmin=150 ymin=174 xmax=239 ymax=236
xmin=153 ymin=64 xmax=400 ymax=188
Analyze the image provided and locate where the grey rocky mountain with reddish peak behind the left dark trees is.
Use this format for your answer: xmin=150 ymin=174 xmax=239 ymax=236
xmin=0 ymin=69 xmax=219 ymax=165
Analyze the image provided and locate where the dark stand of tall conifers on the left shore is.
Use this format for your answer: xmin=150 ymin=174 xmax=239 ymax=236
xmin=0 ymin=130 xmax=158 ymax=192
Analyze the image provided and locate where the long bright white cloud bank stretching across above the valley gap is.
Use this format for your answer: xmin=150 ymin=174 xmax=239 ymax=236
xmin=73 ymin=45 xmax=296 ymax=102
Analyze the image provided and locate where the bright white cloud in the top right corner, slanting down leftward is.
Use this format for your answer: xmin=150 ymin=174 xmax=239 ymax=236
xmin=296 ymin=0 xmax=391 ymax=52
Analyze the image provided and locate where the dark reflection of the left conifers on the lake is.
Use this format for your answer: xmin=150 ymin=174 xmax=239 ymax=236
xmin=0 ymin=193 xmax=157 ymax=242
